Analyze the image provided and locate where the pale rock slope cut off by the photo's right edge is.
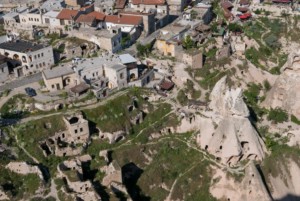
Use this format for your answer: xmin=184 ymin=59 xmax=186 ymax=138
xmin=262 ymin=53 xmax=300 ymax=118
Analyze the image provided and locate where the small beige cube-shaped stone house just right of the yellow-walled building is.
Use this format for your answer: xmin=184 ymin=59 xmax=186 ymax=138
xmin=182 ymin=49 xmax=203 ymax=68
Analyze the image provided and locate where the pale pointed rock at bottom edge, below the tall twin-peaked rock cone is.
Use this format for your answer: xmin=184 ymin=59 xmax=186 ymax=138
xmin=210 ymin=163 xmax=272 ymax=201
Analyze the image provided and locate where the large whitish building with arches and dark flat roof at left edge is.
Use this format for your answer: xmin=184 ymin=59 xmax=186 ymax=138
xmin=0 ymin=40 xmax=54 ymax=77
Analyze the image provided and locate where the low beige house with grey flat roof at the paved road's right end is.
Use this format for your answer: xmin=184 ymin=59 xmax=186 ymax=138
xmin=42 ymin=66 xmax=79 ymax=91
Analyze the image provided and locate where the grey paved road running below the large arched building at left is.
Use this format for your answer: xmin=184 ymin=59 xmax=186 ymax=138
xmin=0 ymin=73 xmax=43 ymax=91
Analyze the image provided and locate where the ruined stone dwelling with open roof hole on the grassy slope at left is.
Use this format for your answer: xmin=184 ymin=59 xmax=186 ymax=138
xmin=40 ymin=112 xmax=90 ymax=156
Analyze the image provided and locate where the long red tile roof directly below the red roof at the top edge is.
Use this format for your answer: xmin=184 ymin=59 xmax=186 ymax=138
xmin=105 ymin=15 xmax=143 ymax=25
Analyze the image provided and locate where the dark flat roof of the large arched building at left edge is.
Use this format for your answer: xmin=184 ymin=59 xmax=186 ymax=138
xmin=0 ymin=40 xmax=46 ymax=53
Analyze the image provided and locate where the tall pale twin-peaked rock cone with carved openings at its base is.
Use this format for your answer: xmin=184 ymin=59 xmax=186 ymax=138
xmin=197 ymin=77 xmax=266 ymax=166
